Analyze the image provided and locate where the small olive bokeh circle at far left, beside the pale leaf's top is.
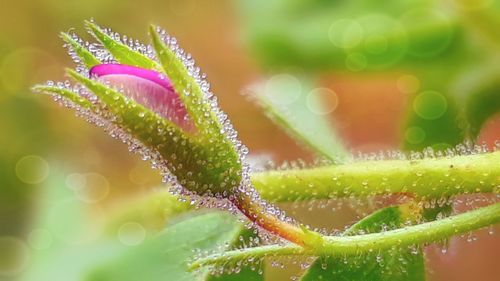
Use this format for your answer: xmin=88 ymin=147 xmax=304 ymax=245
xmin=16 ymin=155 xmax=50 ymax=184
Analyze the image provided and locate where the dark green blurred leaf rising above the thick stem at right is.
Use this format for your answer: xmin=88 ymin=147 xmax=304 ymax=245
xmin=401 ymin=43 xmax=478 ymax=151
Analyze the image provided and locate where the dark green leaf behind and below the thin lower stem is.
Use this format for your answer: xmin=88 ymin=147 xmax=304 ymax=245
xmin=301 ymin=205 xmax=425 ymax=281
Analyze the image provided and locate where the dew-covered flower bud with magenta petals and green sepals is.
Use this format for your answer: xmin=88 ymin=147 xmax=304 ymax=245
xmin=35 ymin=22 xmax=245 ymax=198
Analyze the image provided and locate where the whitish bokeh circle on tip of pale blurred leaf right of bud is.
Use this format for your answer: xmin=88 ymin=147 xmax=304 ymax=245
xmin=264 ymin=74 xmax=302 ymax=105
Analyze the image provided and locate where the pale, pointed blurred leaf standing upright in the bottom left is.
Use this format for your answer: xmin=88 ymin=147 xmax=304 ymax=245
xmin=21 ymin=167 xmax=125 ymax=281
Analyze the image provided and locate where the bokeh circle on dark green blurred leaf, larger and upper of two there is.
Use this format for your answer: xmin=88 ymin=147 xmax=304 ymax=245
xmin=413 ymin=91 xmax=448 ymax=120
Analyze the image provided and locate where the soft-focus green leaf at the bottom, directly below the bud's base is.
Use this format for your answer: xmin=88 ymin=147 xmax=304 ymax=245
xmin=86 ymin=212 xmax=245 ymax=281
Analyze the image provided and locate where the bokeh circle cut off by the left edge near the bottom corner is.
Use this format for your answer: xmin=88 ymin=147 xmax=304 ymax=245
xmin=0 ymin=236 xmax=30 ymax=277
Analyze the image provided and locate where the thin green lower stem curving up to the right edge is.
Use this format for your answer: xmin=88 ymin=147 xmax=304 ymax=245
xmin=191 ymin=200 xmax=500 ymax=269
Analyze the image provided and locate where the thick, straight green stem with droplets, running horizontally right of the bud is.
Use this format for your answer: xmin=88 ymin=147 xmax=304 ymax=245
xmin=252 ymin=152 xmax=500 ymax=202
